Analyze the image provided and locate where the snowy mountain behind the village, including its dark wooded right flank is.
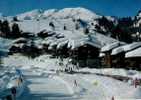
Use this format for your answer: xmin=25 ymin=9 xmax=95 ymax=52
xmin=0 ymin=7 xmax=141 ymax=43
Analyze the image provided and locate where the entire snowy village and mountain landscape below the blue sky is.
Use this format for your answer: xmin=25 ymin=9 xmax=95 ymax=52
xmin=0 ymin=7 xmax=141 ymax=100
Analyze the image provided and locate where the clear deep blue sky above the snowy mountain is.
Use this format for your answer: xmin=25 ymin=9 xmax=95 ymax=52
xmin=0 ymin=0 xmax=141 ymax=17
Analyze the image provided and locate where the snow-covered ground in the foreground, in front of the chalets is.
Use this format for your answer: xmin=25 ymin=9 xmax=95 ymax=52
xmin=3 ymin=54 xmax=141 ymax=100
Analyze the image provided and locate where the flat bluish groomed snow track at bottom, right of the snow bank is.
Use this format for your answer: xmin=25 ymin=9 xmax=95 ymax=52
xmin=19 ymin=71 xmax=77 ymax=100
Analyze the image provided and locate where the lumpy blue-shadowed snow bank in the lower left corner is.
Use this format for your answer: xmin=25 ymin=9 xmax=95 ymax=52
xmin=0 ymin=69 xmax=25 ymax=98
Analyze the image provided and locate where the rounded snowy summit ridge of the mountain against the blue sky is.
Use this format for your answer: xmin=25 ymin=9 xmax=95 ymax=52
xmin=17 ymin=7 xmax=100 ymax=21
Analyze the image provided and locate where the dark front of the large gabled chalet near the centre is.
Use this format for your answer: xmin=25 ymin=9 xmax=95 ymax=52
xmin=70 ymin=43 xmax=100 ymax=68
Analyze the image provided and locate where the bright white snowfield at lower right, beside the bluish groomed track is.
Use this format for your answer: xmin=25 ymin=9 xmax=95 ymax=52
xmin=62 ymin=74 xmax=141 ymax=100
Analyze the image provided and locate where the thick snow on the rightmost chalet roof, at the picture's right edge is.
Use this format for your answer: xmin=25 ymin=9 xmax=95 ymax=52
xmin=125 ymin=47 xmax=141 ymax=58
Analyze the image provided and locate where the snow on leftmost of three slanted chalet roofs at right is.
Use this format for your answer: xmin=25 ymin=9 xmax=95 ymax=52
xmin=101 ymin=42 xmax=121 ymax=52
